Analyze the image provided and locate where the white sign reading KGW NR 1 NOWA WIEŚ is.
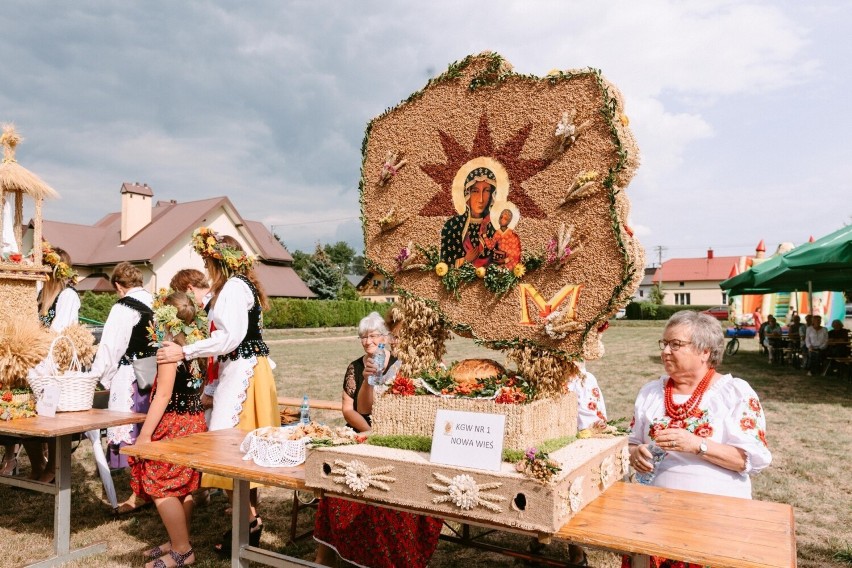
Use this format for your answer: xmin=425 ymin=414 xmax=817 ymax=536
xmin=429 ymin=409 xmax=506 ymax=471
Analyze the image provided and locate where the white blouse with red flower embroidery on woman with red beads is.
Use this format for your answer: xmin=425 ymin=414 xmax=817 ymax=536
xmin=629 ymin=374 xmax=772 ymax=499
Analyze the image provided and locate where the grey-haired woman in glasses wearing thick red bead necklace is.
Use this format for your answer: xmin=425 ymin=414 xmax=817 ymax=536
xmin=629 ymin=311 xmax=772 ymax=499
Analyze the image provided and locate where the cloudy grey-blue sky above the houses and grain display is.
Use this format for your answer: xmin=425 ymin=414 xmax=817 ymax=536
xmin=0 ymin=0 xmax=852 ymax=261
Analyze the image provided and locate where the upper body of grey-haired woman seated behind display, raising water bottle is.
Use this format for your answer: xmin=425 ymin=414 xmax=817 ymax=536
xmin=342 ymin=312 xmax=396 ymax=432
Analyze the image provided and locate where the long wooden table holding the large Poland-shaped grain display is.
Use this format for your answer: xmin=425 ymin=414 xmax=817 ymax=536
xmin=122 ymin=429 xmax=796 ymax=568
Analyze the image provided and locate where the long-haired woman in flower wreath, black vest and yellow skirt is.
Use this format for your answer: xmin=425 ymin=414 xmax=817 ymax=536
xmin=157 ymin=227 xmax=281 ymax=554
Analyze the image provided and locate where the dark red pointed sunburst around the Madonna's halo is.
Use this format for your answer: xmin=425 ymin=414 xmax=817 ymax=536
xmin=420 ymin=114 xmax=550 ymax=219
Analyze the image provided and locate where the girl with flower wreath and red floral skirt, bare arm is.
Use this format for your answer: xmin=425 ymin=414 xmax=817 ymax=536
xmin=128 ymin=291 xmax=207 ymax=568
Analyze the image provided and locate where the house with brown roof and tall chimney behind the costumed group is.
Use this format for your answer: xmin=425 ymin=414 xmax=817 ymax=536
xmin=25 ymin=182 xmax=315 ymax=298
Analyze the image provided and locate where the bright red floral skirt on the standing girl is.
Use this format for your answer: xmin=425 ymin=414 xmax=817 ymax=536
xmin=128 ymin=412 xmax=207 ymax=501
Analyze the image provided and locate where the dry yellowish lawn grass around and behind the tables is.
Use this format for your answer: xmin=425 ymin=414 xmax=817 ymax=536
xmin=0 ymin=321 xmax=852 ymax=568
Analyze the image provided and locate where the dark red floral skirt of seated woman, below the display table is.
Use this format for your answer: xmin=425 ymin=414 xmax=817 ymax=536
xmin=314 ymin=497 xmax=443 ymax=568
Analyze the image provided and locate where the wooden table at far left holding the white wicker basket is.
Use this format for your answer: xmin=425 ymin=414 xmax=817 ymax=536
xmin=0 ymin=409 xmax=145 ymax=566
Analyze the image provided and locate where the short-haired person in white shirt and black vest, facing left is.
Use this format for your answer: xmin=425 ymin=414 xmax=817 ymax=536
xmin=92 ymin=262 xmax=156 ymax=513
